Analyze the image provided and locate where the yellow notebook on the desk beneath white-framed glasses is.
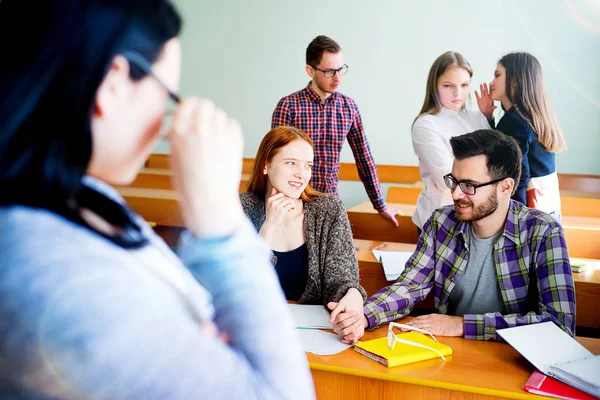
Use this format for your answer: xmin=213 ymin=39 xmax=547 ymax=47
xmin=354 ymin=332 xmax=452 ymax=367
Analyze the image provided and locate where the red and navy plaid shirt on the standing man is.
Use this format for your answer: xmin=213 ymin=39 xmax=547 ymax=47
xmin=271 ymin=82 xmax=387 ymax=211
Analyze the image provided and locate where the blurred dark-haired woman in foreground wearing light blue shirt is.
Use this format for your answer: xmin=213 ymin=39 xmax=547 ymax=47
xmin=0 ymin=0 xmax=314 ymax=399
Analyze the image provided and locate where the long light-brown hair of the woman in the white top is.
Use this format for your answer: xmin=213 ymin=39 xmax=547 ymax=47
xmin=413 ymin=51 xmax=473 ymax=125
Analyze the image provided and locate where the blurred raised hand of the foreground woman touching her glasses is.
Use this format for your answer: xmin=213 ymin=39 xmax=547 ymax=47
xmin=168 ymin=97 xmax=244 ymax=238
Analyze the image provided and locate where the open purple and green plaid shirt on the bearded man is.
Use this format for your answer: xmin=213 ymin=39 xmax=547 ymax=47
xmin=365 ymin=200 xmax=575 ymax=340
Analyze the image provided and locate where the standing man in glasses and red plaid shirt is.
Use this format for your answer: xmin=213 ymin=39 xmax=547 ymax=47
xmin=271 ymin=35 xmax=401 ymax=227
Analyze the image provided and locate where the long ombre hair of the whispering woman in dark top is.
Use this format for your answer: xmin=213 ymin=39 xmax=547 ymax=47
xmin=498 ymin=53 xmax=567 ymax=153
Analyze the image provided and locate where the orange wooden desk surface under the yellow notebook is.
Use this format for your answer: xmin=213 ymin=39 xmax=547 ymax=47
xmin=307 ymin=325 xmax=600 ymax=400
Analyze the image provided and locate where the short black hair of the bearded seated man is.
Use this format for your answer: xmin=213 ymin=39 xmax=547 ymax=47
xmin=450 ymin=129 xmax=522 ymax=192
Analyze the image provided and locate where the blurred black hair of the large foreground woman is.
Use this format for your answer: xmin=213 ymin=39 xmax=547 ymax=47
xmin=0 ymin=0 xmax=181 ymax=213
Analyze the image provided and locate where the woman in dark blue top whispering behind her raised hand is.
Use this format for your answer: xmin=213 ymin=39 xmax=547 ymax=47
xmin=478 ymin=53 xmax=566 ymax=221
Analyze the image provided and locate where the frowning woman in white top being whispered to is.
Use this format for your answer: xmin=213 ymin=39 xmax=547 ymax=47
xmin=411 ymin=51 xmax=490 ymax=232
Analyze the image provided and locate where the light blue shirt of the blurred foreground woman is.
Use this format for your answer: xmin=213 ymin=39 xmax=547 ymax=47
xmin=0 ymin=178 xmax=314 ymax=399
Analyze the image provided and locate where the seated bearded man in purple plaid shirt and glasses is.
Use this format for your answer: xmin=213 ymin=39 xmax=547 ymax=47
xmin=334 ymin=129 xmax=575 ymax=340
